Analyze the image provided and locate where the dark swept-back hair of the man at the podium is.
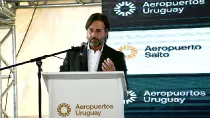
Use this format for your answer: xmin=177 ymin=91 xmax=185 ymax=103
xmin=85 ymin=13 xmax=110 ymax=39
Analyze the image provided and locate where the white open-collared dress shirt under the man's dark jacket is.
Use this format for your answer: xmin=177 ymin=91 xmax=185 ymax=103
xmin=87 ymin=43 xmax=103 ymax=72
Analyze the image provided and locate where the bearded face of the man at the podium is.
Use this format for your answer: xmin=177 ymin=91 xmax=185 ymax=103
xmin=87 ymin=20 xmax=108 ymax=47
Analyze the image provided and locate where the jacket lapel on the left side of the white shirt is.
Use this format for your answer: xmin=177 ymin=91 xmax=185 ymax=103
xmin=79 ymin=44 xmax=88 ymax=71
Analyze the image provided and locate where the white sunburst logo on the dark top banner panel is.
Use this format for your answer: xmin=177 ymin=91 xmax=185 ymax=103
xmin=114 ymin=1 xmax=136 ymax=16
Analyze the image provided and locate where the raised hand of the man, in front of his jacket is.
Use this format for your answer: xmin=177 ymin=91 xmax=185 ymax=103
xmin=102 ymin=58 xmax=115 ymax=71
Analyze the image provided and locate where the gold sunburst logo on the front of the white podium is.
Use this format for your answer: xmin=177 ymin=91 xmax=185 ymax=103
xmin=57 ymin=103 xmax=71 ymax=117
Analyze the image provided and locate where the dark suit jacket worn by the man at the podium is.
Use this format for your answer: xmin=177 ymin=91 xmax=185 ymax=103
xmin=60 ymin=43 xmax=128 ymax=87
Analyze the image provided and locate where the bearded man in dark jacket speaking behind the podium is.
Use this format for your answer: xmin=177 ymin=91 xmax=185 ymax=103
xmin=60 ymin=13 xmax=127 ymax=88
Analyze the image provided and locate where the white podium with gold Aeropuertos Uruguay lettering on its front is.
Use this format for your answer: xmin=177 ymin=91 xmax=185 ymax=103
xmin=42 ymin=71 xmax=127 ymax=118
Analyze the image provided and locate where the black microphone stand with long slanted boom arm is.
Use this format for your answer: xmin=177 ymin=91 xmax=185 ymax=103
xmin=0 ymin=46 xmax=81 ymax=118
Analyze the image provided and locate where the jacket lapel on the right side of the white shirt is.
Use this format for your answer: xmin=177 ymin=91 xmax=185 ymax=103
xmin=97 ymin=43 xmax=108 ymax=71
